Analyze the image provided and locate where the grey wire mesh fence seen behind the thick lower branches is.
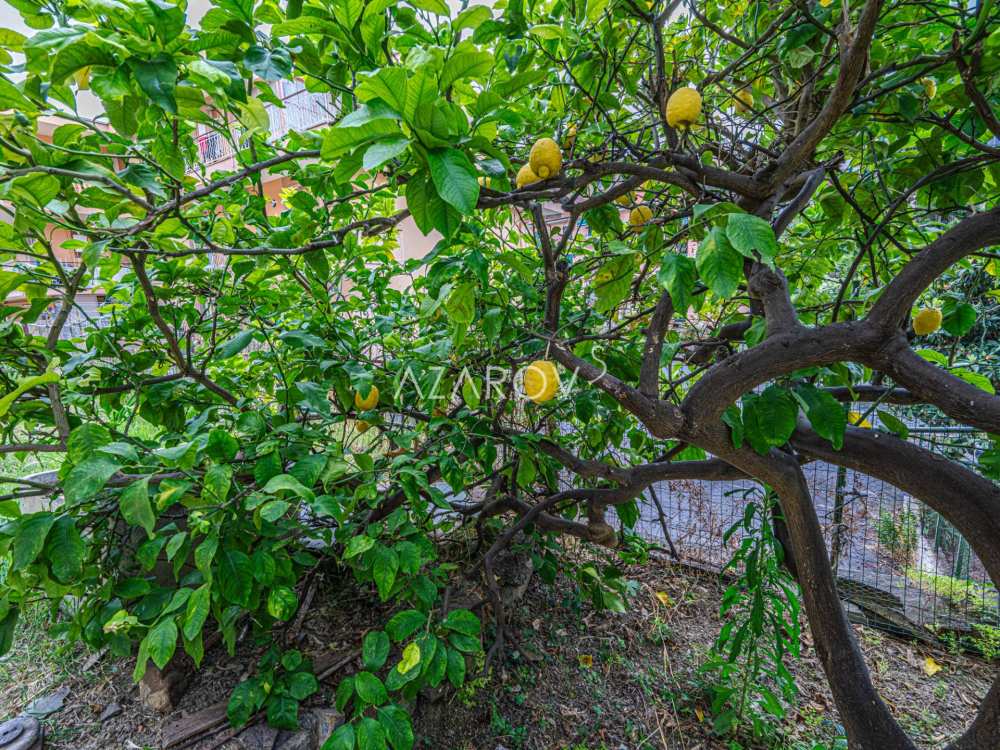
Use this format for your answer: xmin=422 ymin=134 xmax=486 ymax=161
xmin=636 ymin=419 xmax=1000 ymax=637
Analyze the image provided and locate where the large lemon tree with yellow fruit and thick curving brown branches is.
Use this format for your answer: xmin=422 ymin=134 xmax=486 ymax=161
xmin=0 ymin=0 xmax=1000 ymax=750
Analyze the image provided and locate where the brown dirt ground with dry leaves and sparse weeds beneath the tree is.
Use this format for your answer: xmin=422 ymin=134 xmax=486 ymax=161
xmin=0 ymin=561 xmax=995 ymax=750
